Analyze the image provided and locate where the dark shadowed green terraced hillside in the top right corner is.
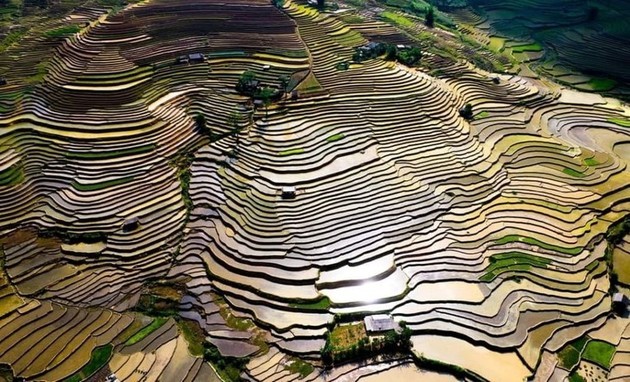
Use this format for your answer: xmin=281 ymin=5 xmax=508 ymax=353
xmin=462 ymin=0 xmax=630 ymax=99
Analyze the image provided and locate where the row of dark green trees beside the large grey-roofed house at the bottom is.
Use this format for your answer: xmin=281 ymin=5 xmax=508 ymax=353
xmin=320 ymin=322 xmax=412 ymax=365
